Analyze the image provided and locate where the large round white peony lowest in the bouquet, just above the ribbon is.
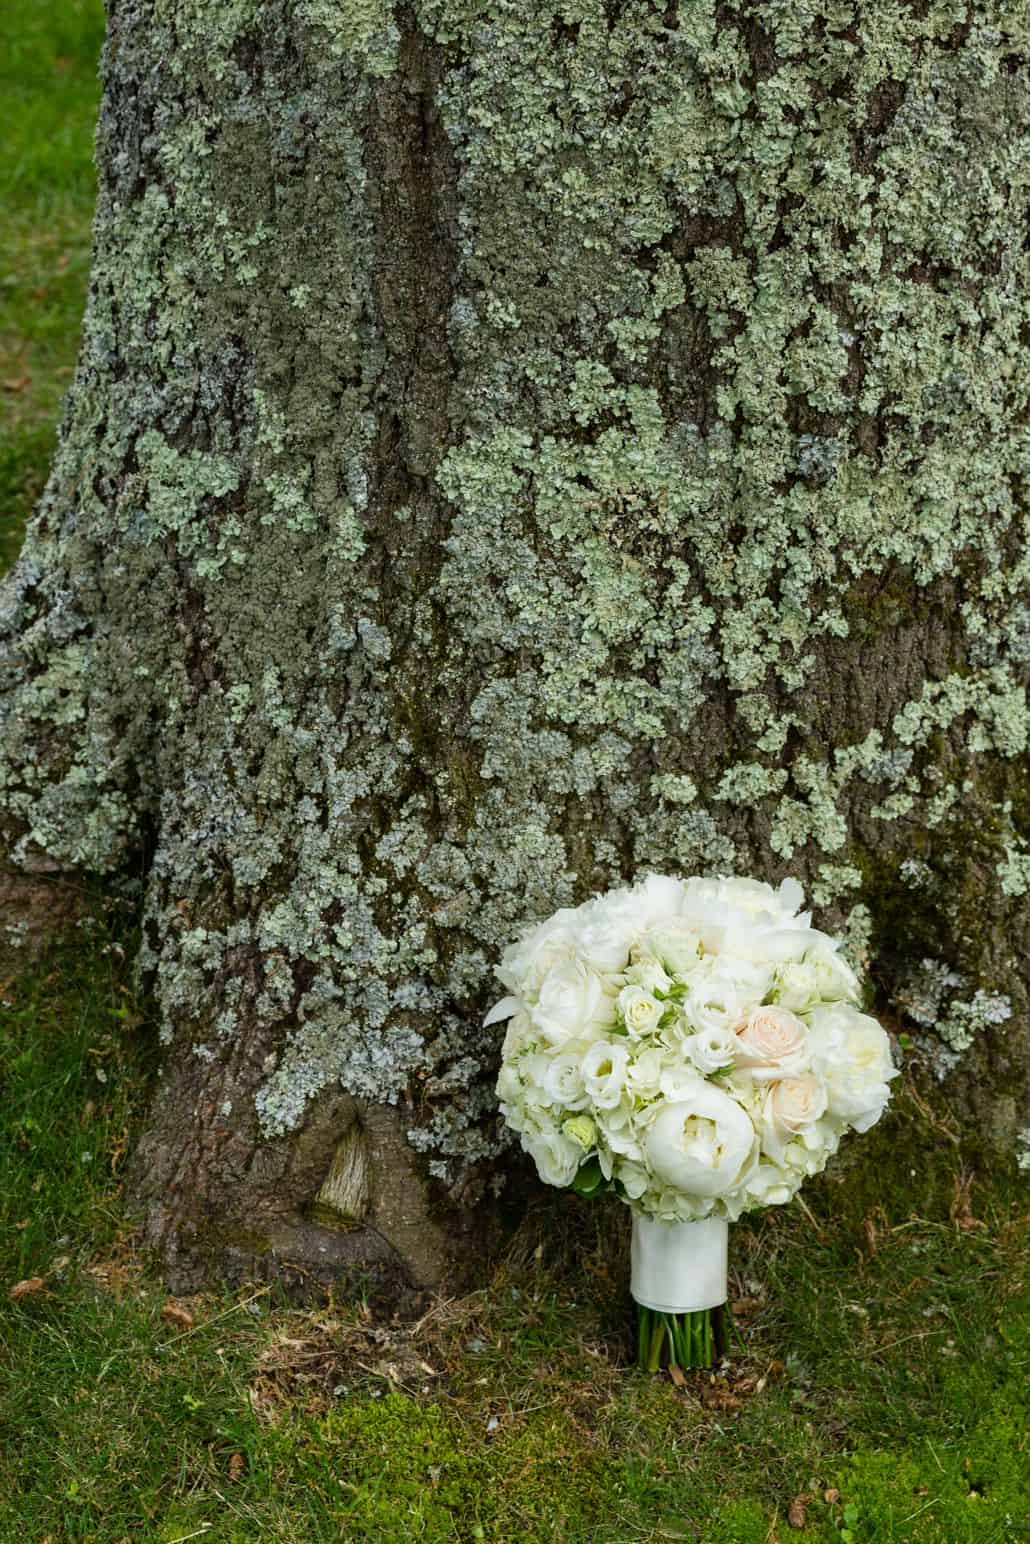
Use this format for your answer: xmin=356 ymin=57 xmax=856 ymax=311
xmin=644 ymin=1078 xmax=757 ymax=1197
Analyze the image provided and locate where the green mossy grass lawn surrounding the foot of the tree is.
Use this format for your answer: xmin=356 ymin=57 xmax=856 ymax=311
xmin=0 ymin=0 xmax=1030 ymax=1544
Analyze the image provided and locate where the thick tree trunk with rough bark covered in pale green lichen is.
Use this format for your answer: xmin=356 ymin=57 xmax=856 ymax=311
xmin=0 ymin=0 xmax=1030 ymax=1283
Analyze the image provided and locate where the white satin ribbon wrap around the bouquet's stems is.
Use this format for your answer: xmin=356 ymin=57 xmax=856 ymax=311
xmin=630 ymin=1212 xmax=729 ymax=1314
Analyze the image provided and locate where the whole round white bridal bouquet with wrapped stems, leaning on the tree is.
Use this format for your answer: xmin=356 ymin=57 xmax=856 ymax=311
xmin=486 ymin=874 xmax=897 ymax=1370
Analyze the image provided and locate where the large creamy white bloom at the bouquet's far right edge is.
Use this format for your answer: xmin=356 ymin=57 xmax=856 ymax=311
xmin=809 ymin=1002 xmax=899 ymax=1132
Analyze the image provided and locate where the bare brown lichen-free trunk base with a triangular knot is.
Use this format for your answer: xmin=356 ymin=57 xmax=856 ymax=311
xmin=127 ymin=1012 xmax=472 ymax=1302
